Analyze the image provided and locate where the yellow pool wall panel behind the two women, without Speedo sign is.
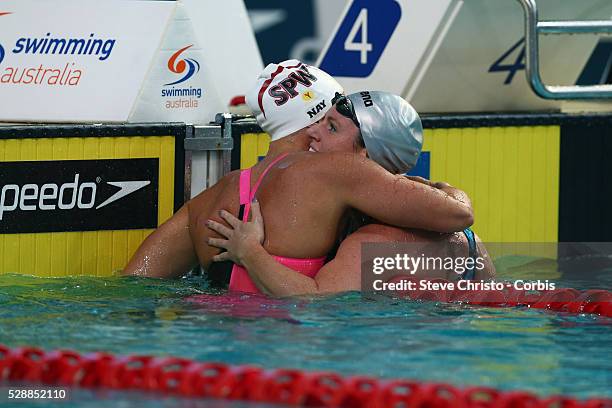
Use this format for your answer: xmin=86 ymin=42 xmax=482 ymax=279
xmin=240 ymin=126 xmax=560 ymax=243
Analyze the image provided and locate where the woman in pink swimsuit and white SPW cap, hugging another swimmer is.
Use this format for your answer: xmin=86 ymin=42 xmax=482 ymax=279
xmin=123 ymin=60 xmax=473 ymax=292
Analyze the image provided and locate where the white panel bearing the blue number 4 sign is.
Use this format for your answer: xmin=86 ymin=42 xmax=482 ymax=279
xmin=318 ymin=0 xmax=462 ymax=95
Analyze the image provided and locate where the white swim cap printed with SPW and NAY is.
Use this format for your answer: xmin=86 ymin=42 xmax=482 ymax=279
xmin=246 ymin=59 xmax=344 ymax=141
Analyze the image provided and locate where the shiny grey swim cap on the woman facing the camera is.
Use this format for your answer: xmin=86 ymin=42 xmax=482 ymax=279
xmin=347 ymin=91 xmax=423 ymax=174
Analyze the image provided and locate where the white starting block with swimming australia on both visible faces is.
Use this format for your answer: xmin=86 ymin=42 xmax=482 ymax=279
xmin=0 ymin=0 xmax=262 ymax=124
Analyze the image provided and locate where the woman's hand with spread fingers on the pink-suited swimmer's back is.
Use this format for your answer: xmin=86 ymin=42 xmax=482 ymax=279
xmin=206 ymin=200 xmax=265 ymax=265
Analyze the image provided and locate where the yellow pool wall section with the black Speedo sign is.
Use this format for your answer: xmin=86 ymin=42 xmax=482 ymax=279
xmin=0 ymin=124 xmax=185 ymax=277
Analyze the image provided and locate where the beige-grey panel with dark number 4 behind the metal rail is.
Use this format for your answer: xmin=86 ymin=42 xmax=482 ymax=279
xmin=404 ymin=0 xmax=612 ymax=112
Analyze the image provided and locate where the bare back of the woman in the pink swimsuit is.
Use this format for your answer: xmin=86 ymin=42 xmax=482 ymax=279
xmin=187 ymin=152 xmax=345 ymax=267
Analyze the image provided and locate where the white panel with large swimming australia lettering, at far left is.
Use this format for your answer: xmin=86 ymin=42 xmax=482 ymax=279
xmin=0 ymin=0 xmax=176 ymax=122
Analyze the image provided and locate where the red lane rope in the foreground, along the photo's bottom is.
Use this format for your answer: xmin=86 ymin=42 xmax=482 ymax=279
xmin=0 ymin=345 xmax=612 ymax=408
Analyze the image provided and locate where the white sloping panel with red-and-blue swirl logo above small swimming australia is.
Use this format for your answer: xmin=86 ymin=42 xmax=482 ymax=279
xmin=130 ymin=0 xmax=263 ymax=124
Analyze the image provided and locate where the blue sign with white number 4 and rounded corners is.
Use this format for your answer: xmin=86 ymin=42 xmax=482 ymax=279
xmin=320 ymin=0 xmax=402 ymax=78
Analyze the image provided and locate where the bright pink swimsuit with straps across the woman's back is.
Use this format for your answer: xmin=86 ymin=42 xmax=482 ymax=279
xmin=229 ymin=153 xmax=325 ymax=293
